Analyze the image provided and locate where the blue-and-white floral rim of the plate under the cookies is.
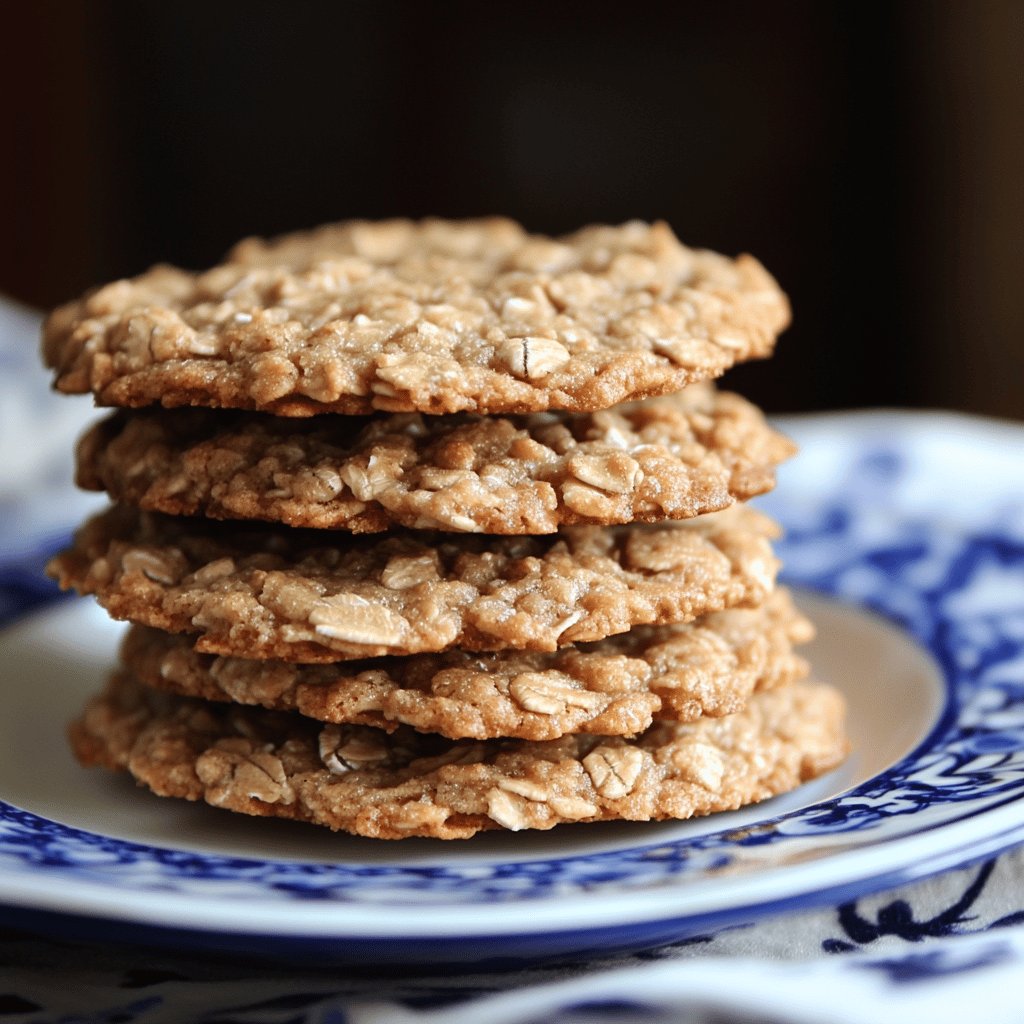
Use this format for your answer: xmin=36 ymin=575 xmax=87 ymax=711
xmin=0 ymin=414 xmax=1024 ymax=963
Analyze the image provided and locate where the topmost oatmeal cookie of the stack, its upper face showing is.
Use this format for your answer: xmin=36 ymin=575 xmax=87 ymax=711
xmin=43 ymin=218 xmax=790 ymax=416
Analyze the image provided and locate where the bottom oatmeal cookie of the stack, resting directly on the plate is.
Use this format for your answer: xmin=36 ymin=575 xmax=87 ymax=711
xmin=71 ymin=674 xmax=847 ymax=839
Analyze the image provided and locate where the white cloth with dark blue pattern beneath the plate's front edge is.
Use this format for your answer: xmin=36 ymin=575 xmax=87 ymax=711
xmin=6 ymin=852 xmax=1024 ymax=1024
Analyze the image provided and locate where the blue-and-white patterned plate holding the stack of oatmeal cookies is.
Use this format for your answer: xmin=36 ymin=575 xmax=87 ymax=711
xmin=0 ymin=414 xmax=1024 ymax=964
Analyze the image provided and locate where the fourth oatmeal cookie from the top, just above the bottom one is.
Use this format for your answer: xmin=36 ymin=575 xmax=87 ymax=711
xmin=121 ymin=590 xmax=813 ymax=740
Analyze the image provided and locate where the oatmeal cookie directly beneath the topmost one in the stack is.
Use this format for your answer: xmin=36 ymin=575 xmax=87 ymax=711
xmin=78 ymin=385 xmax=795 ymax=535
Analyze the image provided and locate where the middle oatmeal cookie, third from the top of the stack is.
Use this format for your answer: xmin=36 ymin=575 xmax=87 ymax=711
xmin=49 ymin=505 xmax=777 ymax=662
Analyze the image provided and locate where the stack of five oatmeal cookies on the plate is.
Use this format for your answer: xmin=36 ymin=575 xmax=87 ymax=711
xmin=44 ymin=219 xmax=847 ymax=839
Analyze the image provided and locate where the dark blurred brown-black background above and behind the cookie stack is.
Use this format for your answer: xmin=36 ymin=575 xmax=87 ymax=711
xmin=0 ymin=0 xmax=1024 ymax=418
